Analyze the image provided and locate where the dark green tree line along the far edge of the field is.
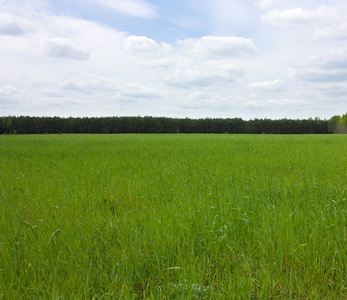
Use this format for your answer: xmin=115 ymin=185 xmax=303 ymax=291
xmin=0 ymin=113 xmax=347 ymax=134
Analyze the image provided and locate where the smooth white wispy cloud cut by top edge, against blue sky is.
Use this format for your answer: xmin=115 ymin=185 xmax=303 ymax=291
xmin=93 ymin=0 xmax=157 ymax=19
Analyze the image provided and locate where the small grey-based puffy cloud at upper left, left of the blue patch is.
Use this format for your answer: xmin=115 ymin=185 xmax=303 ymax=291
xmin=41 ymin=38 xmax=89 ymax=60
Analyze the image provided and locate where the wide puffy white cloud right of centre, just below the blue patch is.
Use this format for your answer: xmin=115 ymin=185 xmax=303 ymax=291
xmin=177 ymin=36 xmax=257 ymax=59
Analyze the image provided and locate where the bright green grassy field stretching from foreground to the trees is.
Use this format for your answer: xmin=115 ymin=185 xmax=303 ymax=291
xmin=0 ymin=134 xmax=347 ymax=299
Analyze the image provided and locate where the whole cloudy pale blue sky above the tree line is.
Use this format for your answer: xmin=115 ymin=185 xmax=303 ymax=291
xmin=0 ymin=0 xmax=347 ymax=120
